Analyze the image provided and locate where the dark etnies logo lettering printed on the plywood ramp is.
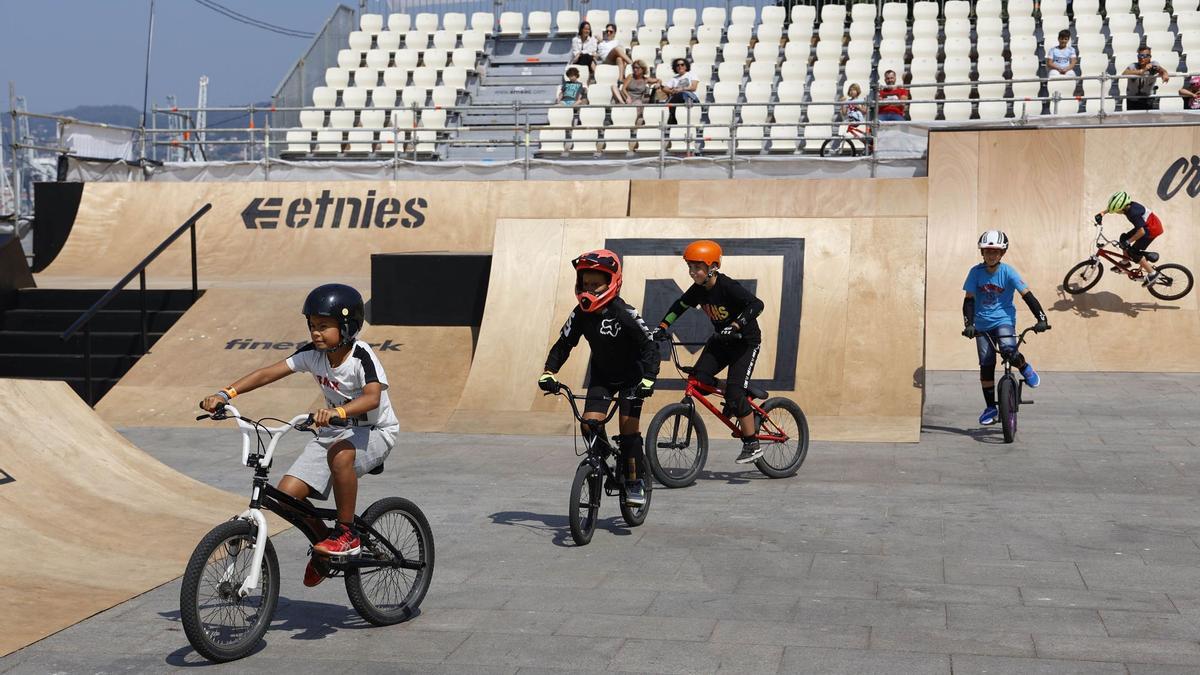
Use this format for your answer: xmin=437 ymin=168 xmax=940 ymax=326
xmin=241 ymin=190 xmax=430 ymax=229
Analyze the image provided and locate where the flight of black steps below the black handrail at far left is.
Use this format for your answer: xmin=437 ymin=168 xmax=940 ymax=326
xmin=0 ymin=288 xmax=193 ymax=402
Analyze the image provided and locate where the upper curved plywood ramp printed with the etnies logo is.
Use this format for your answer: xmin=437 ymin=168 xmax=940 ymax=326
xmin=37 ymin=181 xmax=629 ymax=283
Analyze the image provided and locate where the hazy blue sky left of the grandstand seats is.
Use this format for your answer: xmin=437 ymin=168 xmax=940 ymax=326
xmin=0 ymin=0 xmax=358 ymax=112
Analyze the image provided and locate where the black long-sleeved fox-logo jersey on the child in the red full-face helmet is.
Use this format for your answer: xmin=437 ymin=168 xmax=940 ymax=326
xmin=546 ymin=298 xmax=659 ymax=388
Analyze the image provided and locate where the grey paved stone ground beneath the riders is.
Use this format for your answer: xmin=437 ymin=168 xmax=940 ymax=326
xmin=0 ymin=372 xmax=1200 ymax=675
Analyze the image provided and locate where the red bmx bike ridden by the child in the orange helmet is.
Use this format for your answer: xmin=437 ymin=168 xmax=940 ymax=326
xmin=646 ymin=341 xmax=809 ymax=488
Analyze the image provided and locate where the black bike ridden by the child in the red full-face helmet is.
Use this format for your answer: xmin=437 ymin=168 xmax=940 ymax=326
xmin=547 ymin=384 xmax=653 ymax=546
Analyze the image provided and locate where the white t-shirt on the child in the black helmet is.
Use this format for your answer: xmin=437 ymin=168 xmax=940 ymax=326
xmin=287 ymin=340 xmax=400 ymax=434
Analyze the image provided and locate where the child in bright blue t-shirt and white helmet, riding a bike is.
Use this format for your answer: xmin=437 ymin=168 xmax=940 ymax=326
xmin=962 ymin=229 xmax=1050 ymax=424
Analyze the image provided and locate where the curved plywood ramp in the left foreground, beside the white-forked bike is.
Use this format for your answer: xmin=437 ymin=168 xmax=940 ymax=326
xmin=0 ymin=380 xmax=285 ymax=656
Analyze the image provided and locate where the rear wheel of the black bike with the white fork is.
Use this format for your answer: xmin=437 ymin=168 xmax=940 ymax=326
xmin=346 ymin=497 xmax=434 ymax=626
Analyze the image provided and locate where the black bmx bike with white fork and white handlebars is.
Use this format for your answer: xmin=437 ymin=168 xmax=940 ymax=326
xmin=179 ymin=405 xmax=433 ymax=662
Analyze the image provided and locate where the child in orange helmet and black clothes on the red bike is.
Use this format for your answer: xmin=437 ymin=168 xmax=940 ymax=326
xmin=655 ymin=239 xmax=763 ymax=464
